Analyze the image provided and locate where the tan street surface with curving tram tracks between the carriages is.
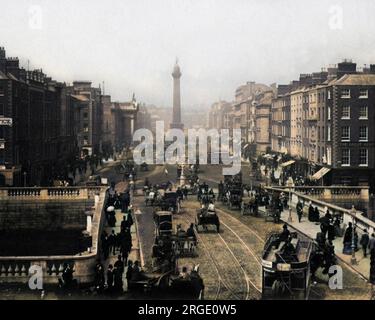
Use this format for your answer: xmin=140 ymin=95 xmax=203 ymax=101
xmin=133 ymin=165 xmax=371 ymax=299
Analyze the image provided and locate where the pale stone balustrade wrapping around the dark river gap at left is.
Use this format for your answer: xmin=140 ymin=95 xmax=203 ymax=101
xmin=0 ymin=187 xmax=107 ymax=285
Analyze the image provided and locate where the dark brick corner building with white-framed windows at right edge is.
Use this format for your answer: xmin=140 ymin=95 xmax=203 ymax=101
xmin=327 ymin=71 xmax=375 ymax=186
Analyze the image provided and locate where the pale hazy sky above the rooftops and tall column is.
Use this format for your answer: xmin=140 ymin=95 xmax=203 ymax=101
xmin=0 ymin=0 xmax=375 ymax=108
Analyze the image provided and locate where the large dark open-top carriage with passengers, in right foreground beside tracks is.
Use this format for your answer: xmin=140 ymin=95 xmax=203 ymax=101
xmin=262 ymin=233 xmax=314 ymax=299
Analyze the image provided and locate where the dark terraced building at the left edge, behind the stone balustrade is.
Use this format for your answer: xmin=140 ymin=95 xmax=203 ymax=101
xmin=0 ymin=48 xmax=75 ymax=185
